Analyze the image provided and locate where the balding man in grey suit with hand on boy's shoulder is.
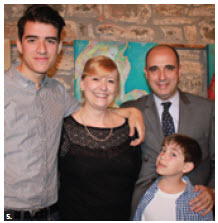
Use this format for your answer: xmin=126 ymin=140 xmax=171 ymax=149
xmin=121 ymin=45 xmax=215 ymax=218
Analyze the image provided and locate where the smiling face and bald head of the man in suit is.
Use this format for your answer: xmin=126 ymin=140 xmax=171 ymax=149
xmin=145 ymin=46 xmax=181 ymax=100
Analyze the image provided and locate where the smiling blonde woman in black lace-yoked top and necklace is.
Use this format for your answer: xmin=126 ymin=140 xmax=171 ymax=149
xmin=59 ymin=56 xmax=141 ymax=221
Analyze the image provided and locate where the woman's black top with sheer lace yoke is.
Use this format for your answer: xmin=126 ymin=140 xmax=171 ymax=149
xmin=59 ymin=116 xmax=141 ymax=221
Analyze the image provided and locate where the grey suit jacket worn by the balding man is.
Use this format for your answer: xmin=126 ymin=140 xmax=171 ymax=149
xmin=121 ymin=91 xmax=215 ymax=216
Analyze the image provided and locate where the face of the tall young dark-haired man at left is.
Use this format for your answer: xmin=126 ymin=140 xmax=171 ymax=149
xmin=17 ymin=21 xmax=61 ymax=78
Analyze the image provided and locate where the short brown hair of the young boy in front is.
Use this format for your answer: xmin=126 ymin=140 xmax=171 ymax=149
xmin=163 ymin=134 xmax=202 ymax=167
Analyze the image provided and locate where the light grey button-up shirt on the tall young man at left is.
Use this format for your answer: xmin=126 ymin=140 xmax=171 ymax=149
xmin=4 ymin=66 xmax=80 ymax=210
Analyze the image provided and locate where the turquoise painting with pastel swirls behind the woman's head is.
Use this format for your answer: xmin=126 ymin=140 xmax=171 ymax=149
xmin=74 ymin=40 xmax=157 ymax=107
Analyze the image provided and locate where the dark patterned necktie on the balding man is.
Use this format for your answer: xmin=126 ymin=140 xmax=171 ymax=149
xmin=161 ymin=102 xmax=175 ymax=136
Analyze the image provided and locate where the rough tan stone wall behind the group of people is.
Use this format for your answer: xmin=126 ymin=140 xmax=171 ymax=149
xmin=4 ymin=4 xmax=215 ymax=96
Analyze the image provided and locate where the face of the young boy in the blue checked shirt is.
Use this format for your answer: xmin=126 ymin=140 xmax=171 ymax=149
xmin=156 ymin=142 xmax=188 ymax=176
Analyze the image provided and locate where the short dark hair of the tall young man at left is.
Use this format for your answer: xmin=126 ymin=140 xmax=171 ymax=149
xmin=17 ymin=4 xmax=65 ymax=42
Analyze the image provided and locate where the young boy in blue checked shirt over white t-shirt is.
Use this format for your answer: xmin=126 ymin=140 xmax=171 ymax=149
xmin=133 ymin=134 xmax=213 ymax=221
